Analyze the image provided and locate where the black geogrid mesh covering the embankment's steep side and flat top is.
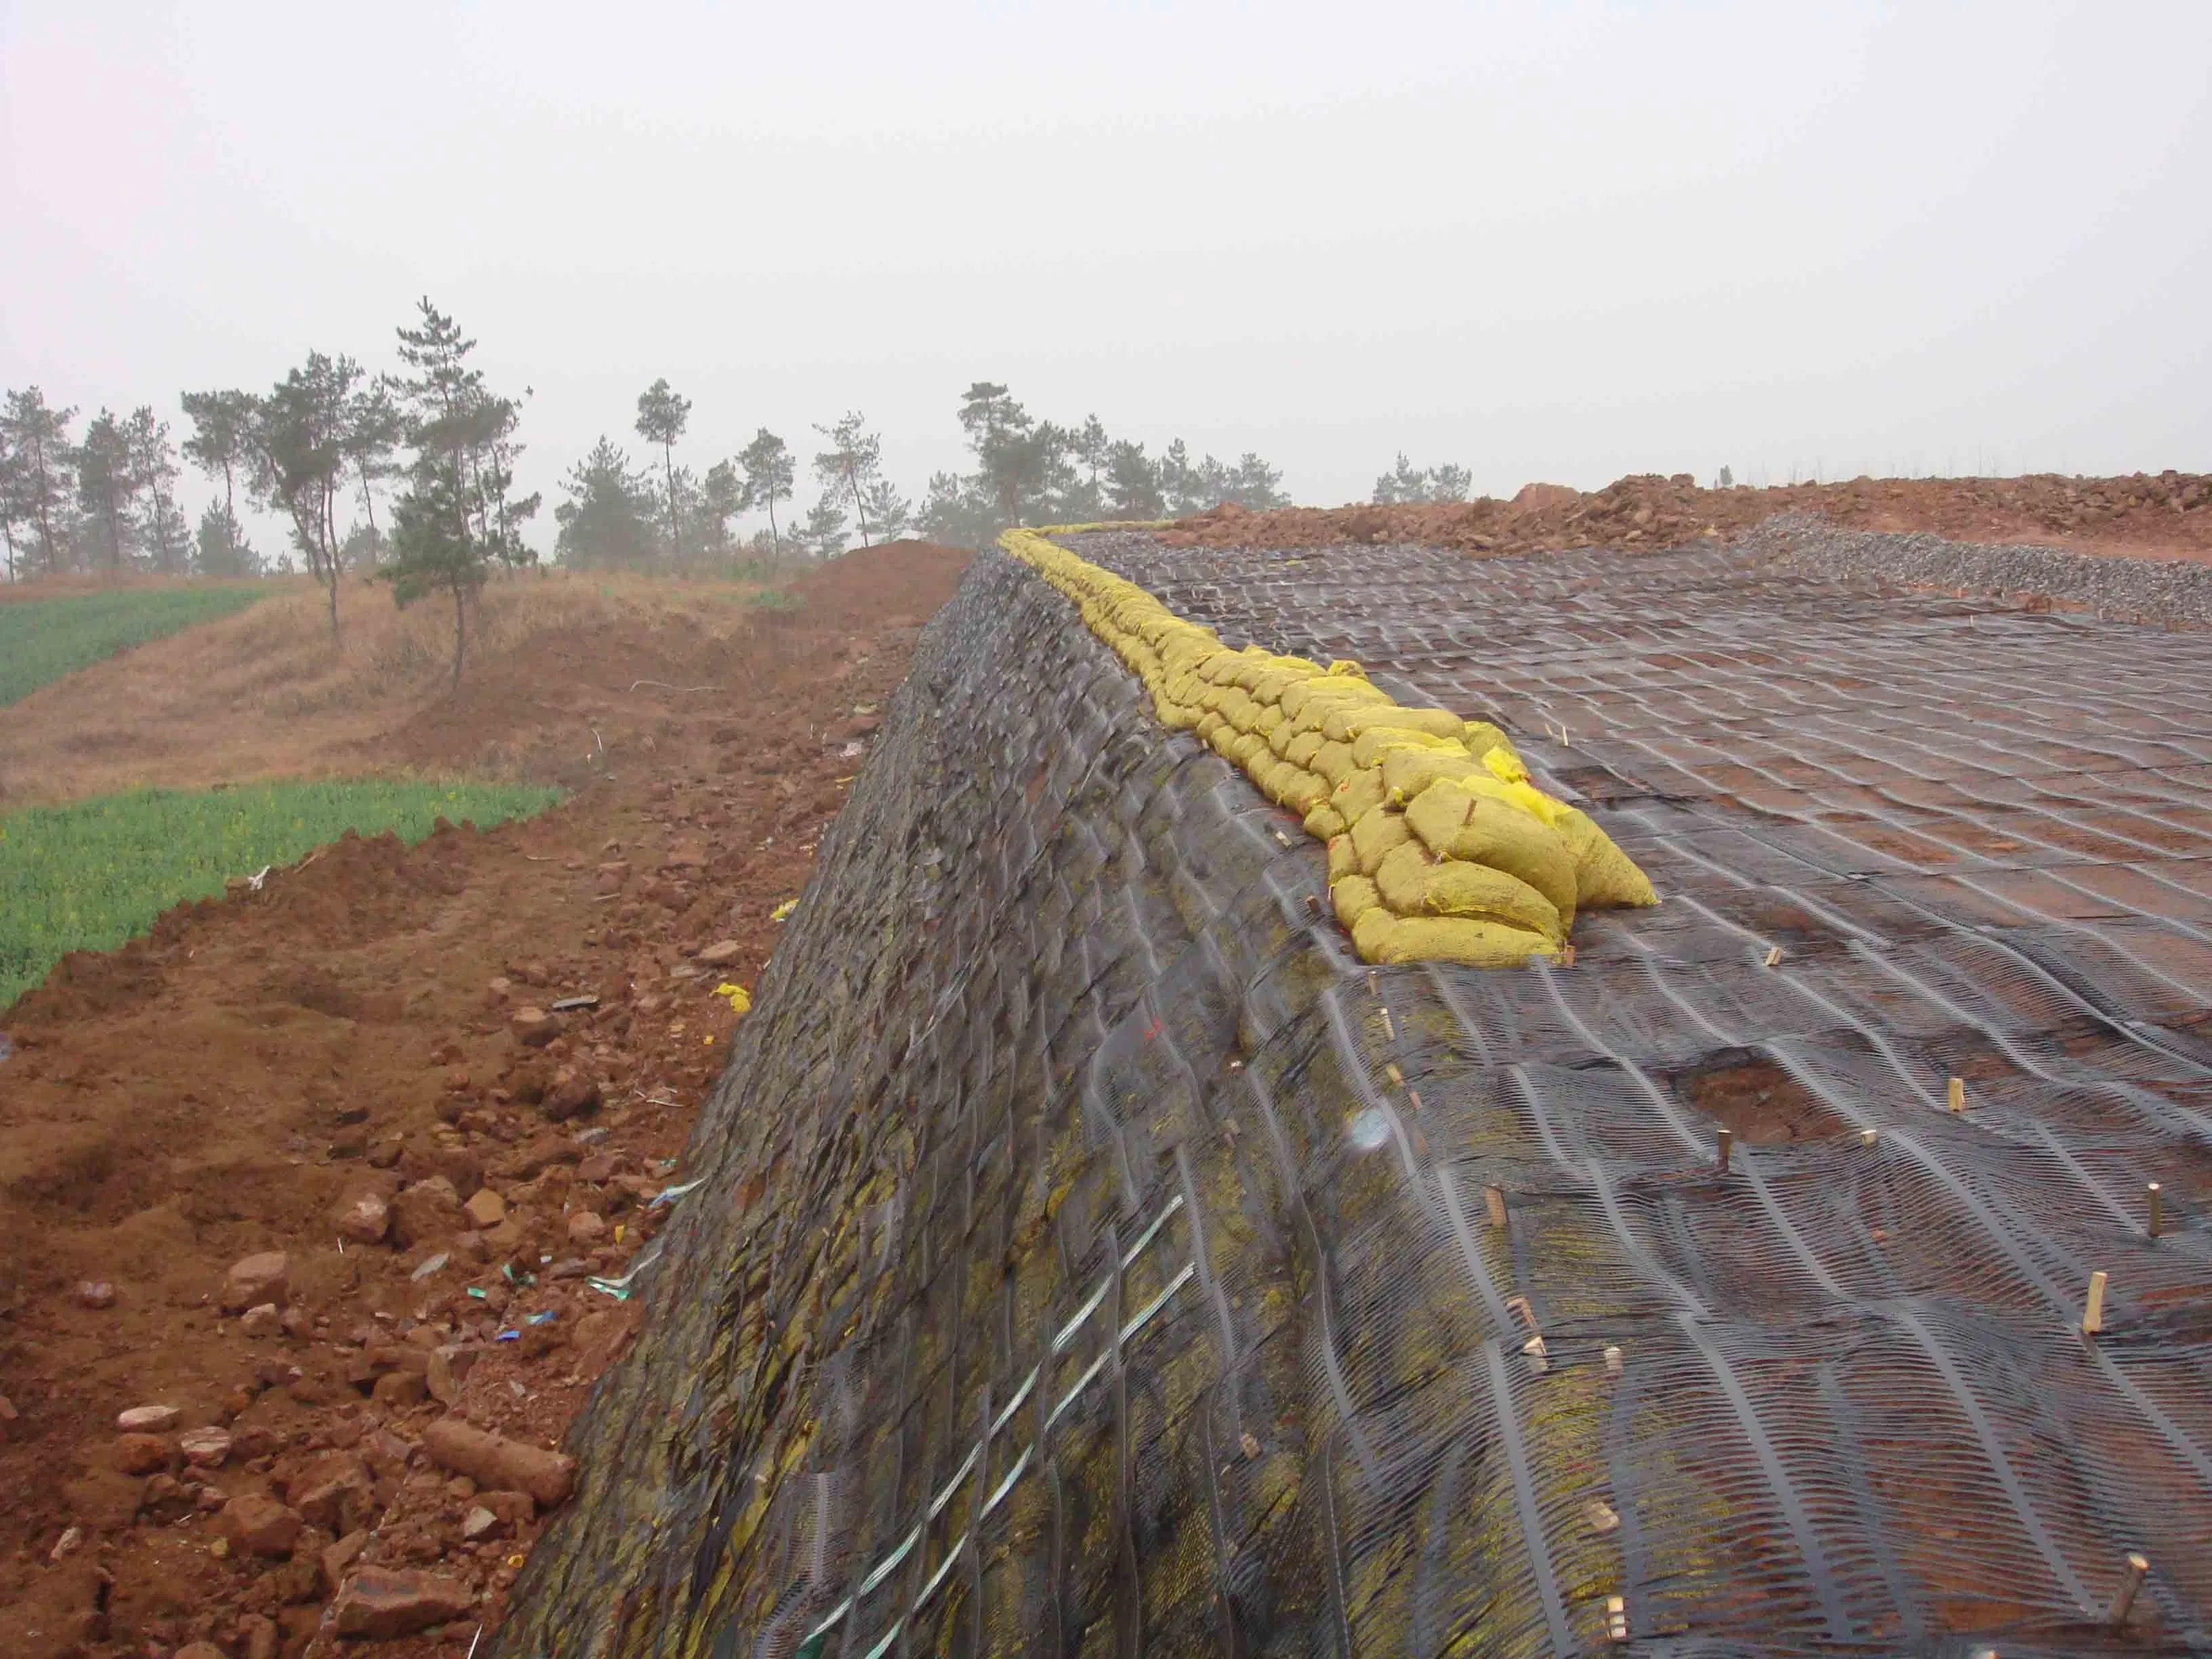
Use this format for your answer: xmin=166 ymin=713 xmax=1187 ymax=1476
xmin=500 ymin=535 xmax=2212 ymax=1659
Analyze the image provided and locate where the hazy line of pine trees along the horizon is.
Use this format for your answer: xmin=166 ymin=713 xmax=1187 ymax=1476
xmin=0 ymin=345 xmax=1318 ymax=606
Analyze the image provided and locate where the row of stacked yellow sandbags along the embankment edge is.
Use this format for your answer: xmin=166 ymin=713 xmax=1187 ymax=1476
xmin=1000 ymin=531 xmax=1657 ymax=966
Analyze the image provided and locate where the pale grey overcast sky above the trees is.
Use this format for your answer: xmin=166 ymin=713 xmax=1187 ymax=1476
xmin=0 ymin=0 xmax=2212 ymax=544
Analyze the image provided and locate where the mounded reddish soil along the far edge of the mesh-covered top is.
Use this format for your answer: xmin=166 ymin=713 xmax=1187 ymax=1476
xmin=1166 ymin=471 xmax=2212 ymax=560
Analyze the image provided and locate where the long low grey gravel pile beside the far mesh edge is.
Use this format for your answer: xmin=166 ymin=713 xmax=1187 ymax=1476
xmin=1734 ymin=513 xmax=2212 ymax=623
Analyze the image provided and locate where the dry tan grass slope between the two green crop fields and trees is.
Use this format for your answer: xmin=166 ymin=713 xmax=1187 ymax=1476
xmin=0 ymin=571 xmax=759 ymax=810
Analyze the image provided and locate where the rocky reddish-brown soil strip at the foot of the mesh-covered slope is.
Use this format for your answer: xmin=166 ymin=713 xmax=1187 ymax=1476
xmin=0 ymin=544 xmax=966 ymax=1659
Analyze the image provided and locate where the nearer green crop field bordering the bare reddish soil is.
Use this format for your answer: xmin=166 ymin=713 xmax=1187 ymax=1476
xmin=0 ymin=781 xmax=560 ymax=1008
